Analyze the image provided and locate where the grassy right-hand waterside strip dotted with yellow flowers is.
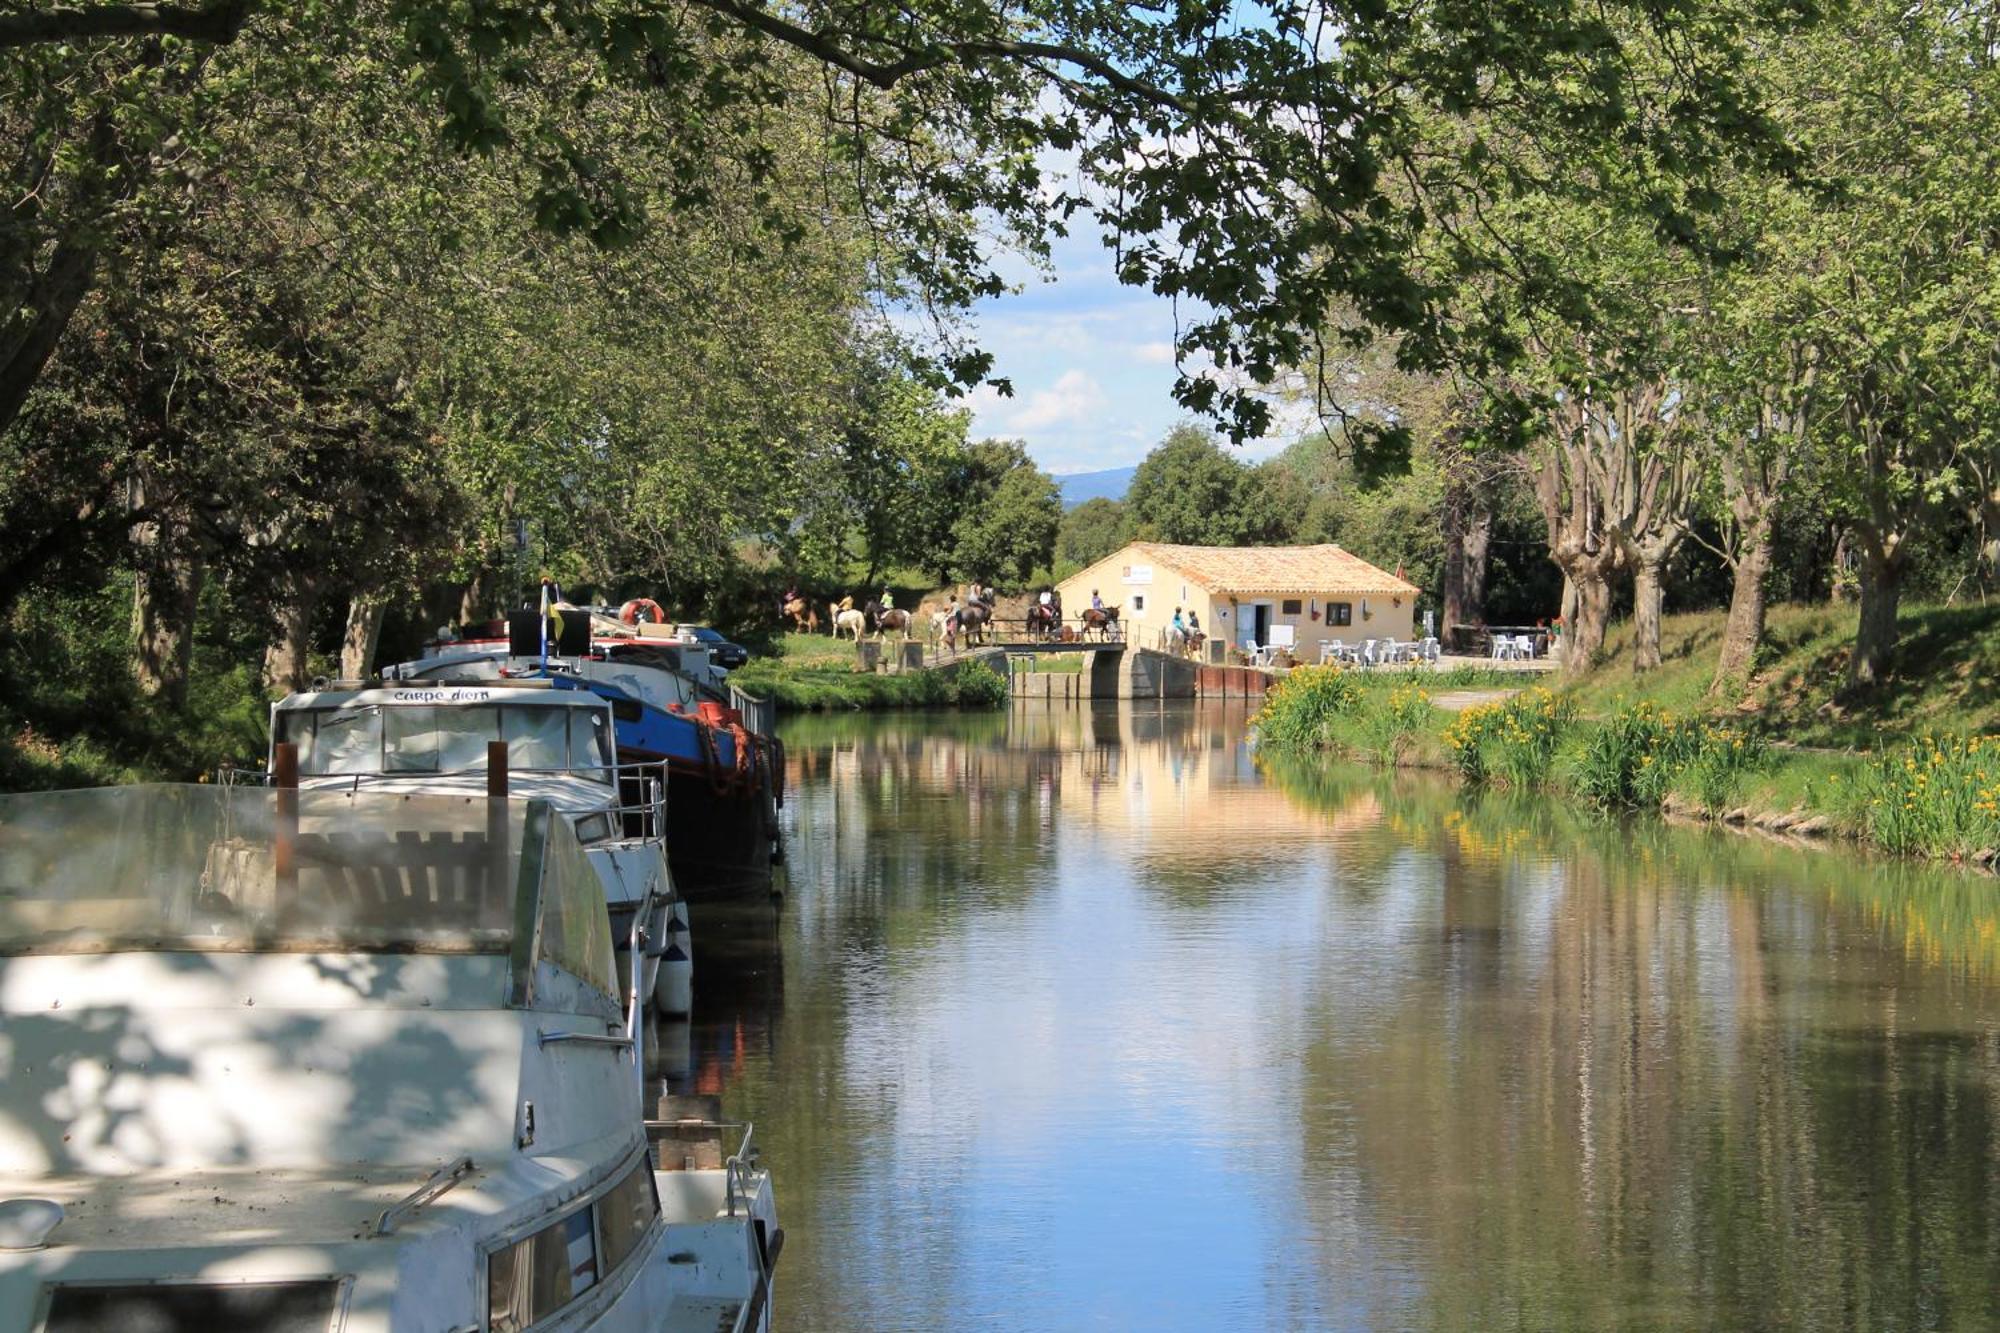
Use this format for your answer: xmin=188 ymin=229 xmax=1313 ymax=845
xmin=1254 ymin=667 xmax=2000 ymax=863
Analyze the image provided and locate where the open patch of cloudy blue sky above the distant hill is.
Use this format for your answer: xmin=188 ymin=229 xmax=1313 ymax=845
xmin=970 ymin=214 xmax=1290 ymax=476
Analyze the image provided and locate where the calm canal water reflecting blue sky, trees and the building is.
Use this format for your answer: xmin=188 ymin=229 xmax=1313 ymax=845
xmin=676 ymin=703 xmax=2000 ymax=1331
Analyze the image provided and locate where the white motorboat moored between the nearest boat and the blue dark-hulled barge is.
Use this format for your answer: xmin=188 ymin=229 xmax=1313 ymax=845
xmin=270 ymin=679 xmax=694 ymax=1015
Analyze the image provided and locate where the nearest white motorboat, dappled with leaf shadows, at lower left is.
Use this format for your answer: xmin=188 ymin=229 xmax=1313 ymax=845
xmin=0 ymin=785 xmax=782 ymax=1333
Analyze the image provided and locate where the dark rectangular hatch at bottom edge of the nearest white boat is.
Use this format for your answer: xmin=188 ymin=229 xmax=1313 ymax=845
xmin=42 ymin=1279 xmax=344 ymax=1333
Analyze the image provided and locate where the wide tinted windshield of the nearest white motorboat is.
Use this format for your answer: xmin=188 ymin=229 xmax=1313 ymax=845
xmin=0 ymin=785 xmax=616 ymax=993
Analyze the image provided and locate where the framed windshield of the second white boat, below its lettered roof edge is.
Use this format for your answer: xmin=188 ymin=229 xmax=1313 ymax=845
xmin=276 ymin=691 xmax=612 ymax=783
